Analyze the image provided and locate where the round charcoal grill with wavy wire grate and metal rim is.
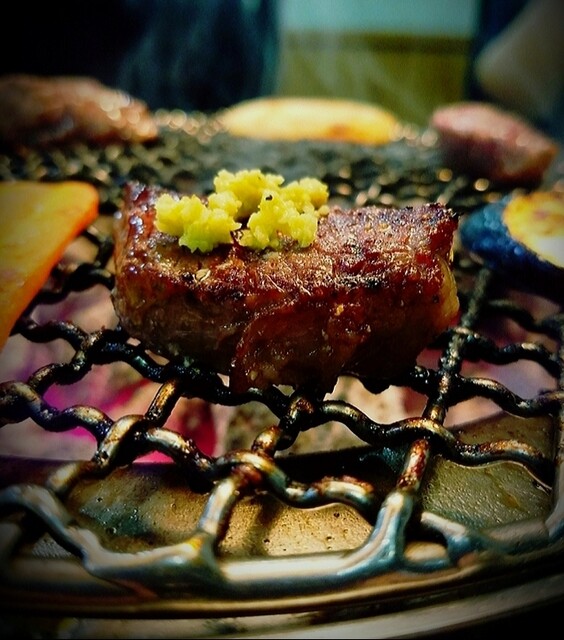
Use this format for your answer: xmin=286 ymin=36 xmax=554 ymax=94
xmin=0 ymin=112 xmax=564 ymax=637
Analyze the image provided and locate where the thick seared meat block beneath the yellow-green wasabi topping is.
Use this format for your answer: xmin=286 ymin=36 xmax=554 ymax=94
xmin=112 ymin=185 xmax=458 ymax=393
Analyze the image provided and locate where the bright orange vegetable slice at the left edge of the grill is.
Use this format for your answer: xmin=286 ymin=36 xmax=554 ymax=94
xmin=0 ymin=180 xmax=99 ymax=349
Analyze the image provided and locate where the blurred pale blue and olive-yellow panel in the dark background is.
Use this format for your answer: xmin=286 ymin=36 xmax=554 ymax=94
xmin=277 ymin=0 xmax=481 ymax=124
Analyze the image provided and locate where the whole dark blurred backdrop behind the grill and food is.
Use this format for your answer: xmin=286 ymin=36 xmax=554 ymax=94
xmin=0 ymin=0 xmax=564 ymax=137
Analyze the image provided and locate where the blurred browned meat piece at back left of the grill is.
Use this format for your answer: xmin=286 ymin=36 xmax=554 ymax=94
xmin=0 ymin=74 xmax=158 ymax=147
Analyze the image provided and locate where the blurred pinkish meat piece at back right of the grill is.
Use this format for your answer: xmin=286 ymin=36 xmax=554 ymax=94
xmin=431 ymin=102 xmax=558 ymax=184
